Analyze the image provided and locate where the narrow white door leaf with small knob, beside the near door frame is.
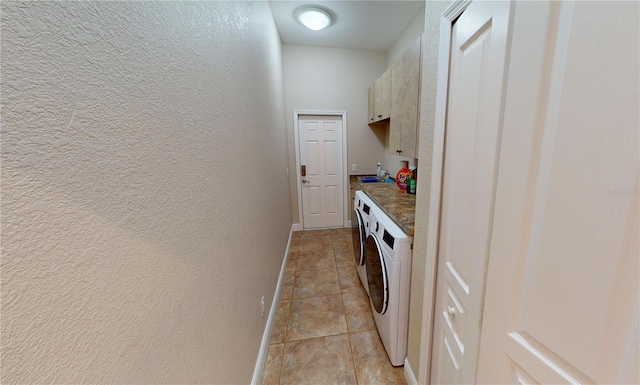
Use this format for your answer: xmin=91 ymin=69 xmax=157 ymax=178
xmin=431 ymin=2 xmax=511 ymax=384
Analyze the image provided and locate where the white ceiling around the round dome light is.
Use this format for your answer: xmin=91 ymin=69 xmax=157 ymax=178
xmin=269 ymin=0 xmax=425 ymax=51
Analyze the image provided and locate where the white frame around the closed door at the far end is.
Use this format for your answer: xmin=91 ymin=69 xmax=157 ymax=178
xmin=293 ymin=110 xmax=351 ymax=231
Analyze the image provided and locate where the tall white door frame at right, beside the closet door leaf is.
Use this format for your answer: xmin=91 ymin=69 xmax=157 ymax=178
xmin=417 ymin=0 xmax=472 ymax=384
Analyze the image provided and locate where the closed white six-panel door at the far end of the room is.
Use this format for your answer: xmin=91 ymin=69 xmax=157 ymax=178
xmin=298 ymin=115 xmax=344 ymax=229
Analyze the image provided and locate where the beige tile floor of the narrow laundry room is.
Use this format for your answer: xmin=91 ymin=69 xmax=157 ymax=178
xmin=262 ymin=229 xmax=406 ymax=385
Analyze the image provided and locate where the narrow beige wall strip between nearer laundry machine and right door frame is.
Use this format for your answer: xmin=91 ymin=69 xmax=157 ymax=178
xmin=407 ymin=1 xmax=451 ymax=377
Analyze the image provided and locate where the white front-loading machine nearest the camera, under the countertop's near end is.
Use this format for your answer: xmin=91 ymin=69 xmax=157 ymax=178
xmin=364 ymin=205 xmax=413 ymax=366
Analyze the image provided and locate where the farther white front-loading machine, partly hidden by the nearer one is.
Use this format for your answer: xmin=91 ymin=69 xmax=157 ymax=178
xmin=351 ymin=190 xmax=373 ymax=295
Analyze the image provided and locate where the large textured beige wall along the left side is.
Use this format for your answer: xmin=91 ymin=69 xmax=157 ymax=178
xmin=0 ymin=1 xmax=291 ymax=384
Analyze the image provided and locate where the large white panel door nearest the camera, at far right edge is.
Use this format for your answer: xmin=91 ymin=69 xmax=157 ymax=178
xmin=477 ymin=2 xmax=640 ymax=384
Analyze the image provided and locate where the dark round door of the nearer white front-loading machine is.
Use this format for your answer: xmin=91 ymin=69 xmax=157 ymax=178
xmin=364 ymin=234 xmax=389 ymax=314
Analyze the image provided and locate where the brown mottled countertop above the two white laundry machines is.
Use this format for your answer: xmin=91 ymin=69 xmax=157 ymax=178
xmin=349 ymin=175 xmax=416 ymax=236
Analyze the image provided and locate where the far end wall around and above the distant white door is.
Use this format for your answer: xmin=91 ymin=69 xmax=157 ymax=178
xmin=282 ymin=44 xmax=387 ymax=222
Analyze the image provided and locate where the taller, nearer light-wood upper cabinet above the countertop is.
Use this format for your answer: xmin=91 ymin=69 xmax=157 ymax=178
xmin=389 ymin=38 xmax=420 ymax=158
